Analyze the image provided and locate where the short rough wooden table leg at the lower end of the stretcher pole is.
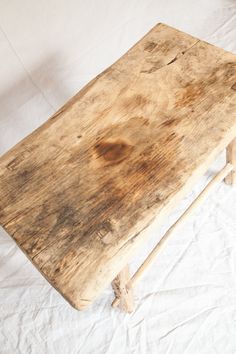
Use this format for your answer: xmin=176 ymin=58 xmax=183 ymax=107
xmin=112 ymin=265 xmax=134 ymax=313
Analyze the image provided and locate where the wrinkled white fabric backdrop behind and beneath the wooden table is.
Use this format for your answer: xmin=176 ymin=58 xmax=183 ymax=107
xmin=0 ymin=0 xmax=236 ymax=354
